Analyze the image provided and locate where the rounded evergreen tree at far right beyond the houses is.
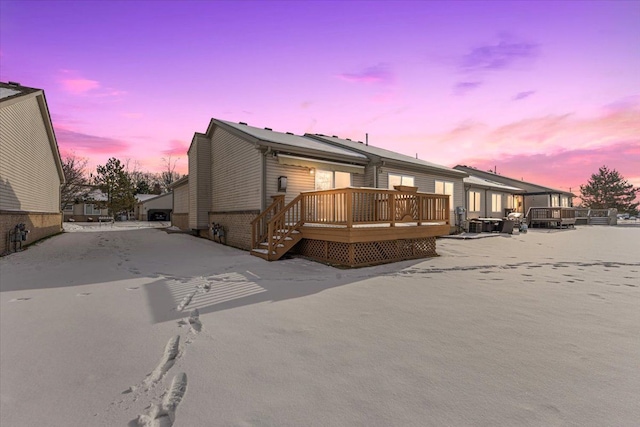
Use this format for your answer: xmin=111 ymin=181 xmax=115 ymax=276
xmin=580 ymin=166 xmax=640 ymax=214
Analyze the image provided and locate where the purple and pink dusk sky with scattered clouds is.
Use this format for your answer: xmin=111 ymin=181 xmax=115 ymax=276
xmin=0 ymin=0 xmax=640 ymax=192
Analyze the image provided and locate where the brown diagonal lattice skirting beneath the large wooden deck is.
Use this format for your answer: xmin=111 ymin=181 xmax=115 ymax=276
xmin=298 ymin=237 xmax=437 ymax=267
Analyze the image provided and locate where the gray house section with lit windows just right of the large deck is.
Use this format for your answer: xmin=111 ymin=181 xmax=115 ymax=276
xmin=464 ymin=176 xmax=524 ymax=219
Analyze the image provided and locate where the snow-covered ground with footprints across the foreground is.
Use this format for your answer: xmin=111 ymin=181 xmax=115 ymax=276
xmin=0 ymin=223 xmax=640 ymax=427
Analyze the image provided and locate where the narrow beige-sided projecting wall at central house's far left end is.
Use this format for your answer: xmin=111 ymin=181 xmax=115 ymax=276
xmin=189 ymin=134 xmax=211 ymax=229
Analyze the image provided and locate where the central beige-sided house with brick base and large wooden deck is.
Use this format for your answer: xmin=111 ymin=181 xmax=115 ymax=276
xmin=188 ymin=119 xmax=467 ymax=265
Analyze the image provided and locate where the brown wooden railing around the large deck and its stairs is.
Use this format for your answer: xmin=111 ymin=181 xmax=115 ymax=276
xmin=252 ymin=188 xmax=450 ymax=253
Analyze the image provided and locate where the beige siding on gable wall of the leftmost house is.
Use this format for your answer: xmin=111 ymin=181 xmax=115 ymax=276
xmin=0 ymin=96 xmax=60 ymax=213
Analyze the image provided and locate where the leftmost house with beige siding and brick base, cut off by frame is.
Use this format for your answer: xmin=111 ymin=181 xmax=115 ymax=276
xmin=0 ymin=82 xmax=64 ymax=254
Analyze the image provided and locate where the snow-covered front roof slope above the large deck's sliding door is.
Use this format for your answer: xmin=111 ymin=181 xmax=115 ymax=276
xmin=214 ymin=119 xmax=367 ymax=160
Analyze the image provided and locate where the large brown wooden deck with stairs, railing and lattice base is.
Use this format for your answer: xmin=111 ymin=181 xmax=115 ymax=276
xmin=251 ymin=187 xmax=450 ymax=266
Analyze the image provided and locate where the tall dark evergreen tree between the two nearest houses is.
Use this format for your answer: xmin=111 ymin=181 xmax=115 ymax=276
xmin=95 ymin=157 xmax=136 ymax=216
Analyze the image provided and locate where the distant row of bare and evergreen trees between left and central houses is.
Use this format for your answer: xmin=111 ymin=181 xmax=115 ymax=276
xmin=60 ymin=154 xmax=182 ymax=216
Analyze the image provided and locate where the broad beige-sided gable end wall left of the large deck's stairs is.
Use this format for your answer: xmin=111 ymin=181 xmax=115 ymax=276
xmin=212 ymin=127 xmax=262 ymax=212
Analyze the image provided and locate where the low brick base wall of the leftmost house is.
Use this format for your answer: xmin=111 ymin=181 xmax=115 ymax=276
xmin=0 ymin=211 xmax=62 ymax=254
